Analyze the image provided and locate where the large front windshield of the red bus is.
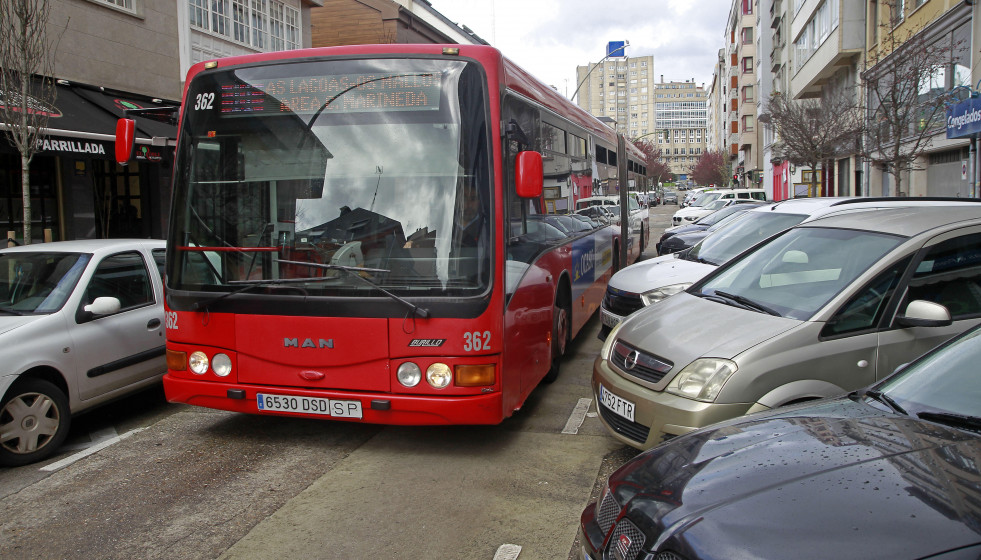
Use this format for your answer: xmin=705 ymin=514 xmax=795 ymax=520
xmin=167 ymin=58 xmax=494 ymax=297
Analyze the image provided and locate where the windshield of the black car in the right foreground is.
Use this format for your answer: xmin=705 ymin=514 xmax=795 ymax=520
xmin=876 ymin=329 xmax=981 ymax=418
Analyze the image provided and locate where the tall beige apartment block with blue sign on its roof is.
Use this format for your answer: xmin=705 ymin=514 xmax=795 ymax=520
xmin=576 ymin=56 xmax=655 ymax=139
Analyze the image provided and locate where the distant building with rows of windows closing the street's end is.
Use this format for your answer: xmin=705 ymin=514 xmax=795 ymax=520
xmin=653 ymin=76 xmax=709 ymax=181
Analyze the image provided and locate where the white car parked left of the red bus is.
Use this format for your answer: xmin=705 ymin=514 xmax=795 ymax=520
xmin=0 ymin=239 xmax=167 ymax=466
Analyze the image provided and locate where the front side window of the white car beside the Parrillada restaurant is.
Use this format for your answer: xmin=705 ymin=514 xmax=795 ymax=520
xmin=85 ymin=252 xmax=153 ymax=311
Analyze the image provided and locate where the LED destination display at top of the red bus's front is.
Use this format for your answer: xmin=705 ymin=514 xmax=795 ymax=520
xmin=219 ymin=72 xmax=442 ymax=117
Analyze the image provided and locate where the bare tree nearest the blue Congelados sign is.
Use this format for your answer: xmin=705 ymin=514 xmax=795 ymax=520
xmin=862 ymin=10 xmax=965 ymax=195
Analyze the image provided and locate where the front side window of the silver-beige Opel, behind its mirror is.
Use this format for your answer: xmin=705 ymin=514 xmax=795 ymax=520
xmin=904 ymin=233 xmax=981 ymax=320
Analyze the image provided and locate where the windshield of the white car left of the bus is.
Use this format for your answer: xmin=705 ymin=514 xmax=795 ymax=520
xmin=0 ymin=251 xmax=92 ymax=315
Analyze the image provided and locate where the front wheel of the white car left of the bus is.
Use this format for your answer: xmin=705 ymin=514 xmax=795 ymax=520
xmin=0 ymin=379 xmax=71 ymax=467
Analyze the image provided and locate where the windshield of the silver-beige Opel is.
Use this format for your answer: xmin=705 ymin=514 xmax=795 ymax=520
xmin=695 ymin=227 xmax=903 ymax=321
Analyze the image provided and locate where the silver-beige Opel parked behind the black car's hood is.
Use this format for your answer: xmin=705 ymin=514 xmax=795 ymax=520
xmin=593 ymin=207 xmax=981 ymax=449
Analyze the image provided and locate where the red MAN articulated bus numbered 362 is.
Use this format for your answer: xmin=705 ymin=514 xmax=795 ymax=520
xmin=123 ymin=45 xmax=648 ymax=425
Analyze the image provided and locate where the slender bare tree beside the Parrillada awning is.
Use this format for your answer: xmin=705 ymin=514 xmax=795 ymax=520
xmin=0 ymin=0 xmax=57 ymax=245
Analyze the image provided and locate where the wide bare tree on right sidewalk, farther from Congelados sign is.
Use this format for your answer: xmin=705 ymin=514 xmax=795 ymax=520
xmin=760 ymin=89 xmax=864 ymax=190
